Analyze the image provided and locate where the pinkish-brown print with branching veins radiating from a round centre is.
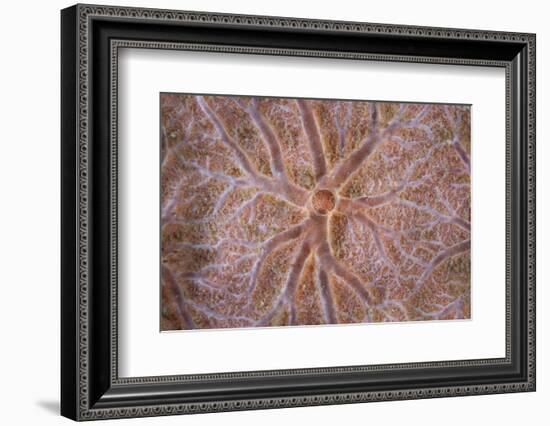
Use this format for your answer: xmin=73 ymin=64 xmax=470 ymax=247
xmin=161 ymin=93 xmax=470 ymax=330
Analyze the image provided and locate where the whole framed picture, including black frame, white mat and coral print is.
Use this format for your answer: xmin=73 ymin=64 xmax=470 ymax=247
xmin=61 ymin=5 xmax=535 ymax=420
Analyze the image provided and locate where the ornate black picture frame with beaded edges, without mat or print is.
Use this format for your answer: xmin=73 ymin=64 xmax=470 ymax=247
xmin=61 ymin=5 xmax=536 ymax=420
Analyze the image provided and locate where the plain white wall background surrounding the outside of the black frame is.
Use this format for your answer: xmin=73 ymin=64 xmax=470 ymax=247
xmin=0 ymin=0 xmax=550 ymax=426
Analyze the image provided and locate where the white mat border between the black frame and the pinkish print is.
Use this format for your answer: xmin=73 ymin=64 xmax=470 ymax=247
xmin=122 ymin=49 xmax=506 ymax=377
